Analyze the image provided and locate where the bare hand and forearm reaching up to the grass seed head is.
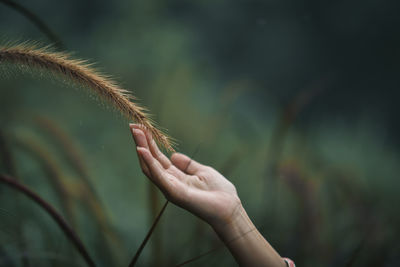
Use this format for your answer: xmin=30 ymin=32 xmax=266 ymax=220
xmin=130 ymin=124 xmax=286 ymax=267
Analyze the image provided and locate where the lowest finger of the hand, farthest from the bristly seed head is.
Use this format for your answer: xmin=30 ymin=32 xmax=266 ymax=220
xmin=137 ymin=147 xmax=169 ymax=192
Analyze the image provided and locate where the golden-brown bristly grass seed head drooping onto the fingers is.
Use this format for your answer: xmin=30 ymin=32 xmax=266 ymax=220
xmin=0 ymin=44 xmax=174 ymax=151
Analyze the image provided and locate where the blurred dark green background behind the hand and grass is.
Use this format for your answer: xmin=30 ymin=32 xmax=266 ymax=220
xmin=0 ymin=0 xmax=400 ymax=266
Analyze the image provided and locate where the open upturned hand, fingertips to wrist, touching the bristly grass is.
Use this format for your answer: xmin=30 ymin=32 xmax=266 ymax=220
xmin=130 ymin=124 xmax=242 ymax=228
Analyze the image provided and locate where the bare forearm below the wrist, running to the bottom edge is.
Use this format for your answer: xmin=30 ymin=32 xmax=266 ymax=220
xmin=212 ymin=205 xmax=286 ymax=267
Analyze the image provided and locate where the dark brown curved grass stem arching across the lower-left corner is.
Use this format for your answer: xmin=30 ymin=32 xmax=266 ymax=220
xmin=0 ymin=174 xmax=96 ymax=266
